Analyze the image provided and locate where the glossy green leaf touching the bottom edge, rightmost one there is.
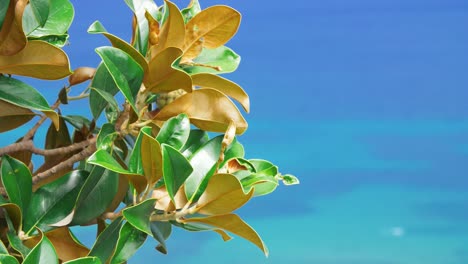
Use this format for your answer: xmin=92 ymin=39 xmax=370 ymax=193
xmin=110 ymin=222 xmax=148 ymax=264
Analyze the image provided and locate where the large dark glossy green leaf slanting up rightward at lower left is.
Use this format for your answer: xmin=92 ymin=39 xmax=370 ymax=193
xmin=24 ymin=170 xmax=89 ymax=234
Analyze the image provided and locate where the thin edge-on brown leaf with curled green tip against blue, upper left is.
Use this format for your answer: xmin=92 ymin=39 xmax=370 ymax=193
xmin=88 ymin=21 xmax=148 ymax=70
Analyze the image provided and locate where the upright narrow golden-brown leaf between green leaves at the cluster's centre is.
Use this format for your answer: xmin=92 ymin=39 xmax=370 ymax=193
xmin=141 ymin=133 xmax=163 ymax=186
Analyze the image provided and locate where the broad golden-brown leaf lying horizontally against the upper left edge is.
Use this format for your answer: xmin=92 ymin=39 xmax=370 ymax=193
xmin=0 ymin=40 xmax=71 ymax=80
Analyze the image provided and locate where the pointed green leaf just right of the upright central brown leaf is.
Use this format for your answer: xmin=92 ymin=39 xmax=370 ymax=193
xmin=161 ymin=144 xmax=193 ymax=201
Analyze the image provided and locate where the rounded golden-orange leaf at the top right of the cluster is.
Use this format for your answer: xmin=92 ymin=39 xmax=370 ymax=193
xmin=184 ymin=5 xmax=241 ymax=59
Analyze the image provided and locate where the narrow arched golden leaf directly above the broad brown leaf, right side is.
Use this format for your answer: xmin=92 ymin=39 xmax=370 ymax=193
xmin=191 ymin=73 xmax=250 ymax=113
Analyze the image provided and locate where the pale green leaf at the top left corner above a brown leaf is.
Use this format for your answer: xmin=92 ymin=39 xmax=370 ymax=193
xmin=23 ymin=0 xmax=75 ymax=37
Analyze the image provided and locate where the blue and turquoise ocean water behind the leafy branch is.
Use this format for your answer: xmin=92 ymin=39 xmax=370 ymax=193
xmin=2 ymin=0 xmax=468 ymax=264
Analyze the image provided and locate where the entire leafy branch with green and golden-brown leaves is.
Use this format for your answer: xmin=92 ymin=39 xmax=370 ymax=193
xmin=0 ymin=0 xmax=298 ymax=264
